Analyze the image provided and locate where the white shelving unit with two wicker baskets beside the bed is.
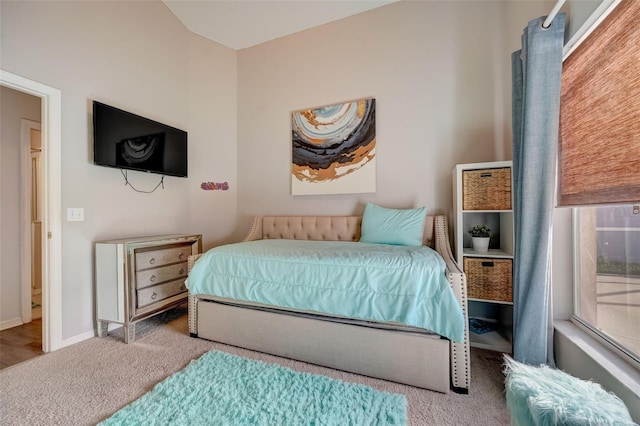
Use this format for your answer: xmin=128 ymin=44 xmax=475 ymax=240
xmin=453 ymin=161 xmax=514 ymax=353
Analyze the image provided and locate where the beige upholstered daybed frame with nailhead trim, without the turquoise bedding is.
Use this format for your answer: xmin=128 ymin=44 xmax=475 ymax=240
xmin=189 ymin=216 xmax=470 ymax=393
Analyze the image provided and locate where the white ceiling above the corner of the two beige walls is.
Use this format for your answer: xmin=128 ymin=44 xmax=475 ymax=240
xmin=163 ymin=0 xmax=399 ymax=50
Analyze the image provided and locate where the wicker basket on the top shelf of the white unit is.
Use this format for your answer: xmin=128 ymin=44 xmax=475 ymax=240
xmin=462 ymin=167 xmax=511 ymax=210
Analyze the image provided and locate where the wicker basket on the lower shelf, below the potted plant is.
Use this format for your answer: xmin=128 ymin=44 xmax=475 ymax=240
xmin=464 ymin=257 xmax=513 ymax=302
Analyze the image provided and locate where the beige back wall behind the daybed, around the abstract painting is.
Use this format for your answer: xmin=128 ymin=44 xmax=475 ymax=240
xmin=238 ymin=2 xmax=510 ymax=236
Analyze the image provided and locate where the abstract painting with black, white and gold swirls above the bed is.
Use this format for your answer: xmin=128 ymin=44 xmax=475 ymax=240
xmin=291 ymin=98 xmax=376 ymax=195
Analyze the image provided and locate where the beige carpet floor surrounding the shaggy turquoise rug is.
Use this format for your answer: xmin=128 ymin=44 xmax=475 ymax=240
xmin=0 ymin=308 xmax=510 ymax=426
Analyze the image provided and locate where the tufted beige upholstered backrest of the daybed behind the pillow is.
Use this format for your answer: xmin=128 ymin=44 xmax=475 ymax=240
xmin=244 ymin=216 xmax=435 ymax=248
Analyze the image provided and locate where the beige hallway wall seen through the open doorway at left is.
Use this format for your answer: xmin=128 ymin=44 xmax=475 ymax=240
xmin=0 ymin=87 xmax=40 ymax=329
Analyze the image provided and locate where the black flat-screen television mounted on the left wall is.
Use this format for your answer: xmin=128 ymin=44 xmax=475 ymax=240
xmin=93 ymin=101 xmax=187 ymax=177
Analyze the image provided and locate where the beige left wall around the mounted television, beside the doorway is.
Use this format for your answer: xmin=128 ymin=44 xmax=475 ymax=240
xmin=0 ymin=1 xmax=237 ymax=339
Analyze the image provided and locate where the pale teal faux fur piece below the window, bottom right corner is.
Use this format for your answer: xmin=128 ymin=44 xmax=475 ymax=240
xmin=504 ymin=355 xmax=636 ymax=426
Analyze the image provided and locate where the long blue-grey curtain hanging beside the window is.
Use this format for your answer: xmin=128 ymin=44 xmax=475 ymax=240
xmin=511 ymin=14 xmax=565 ymax=365
